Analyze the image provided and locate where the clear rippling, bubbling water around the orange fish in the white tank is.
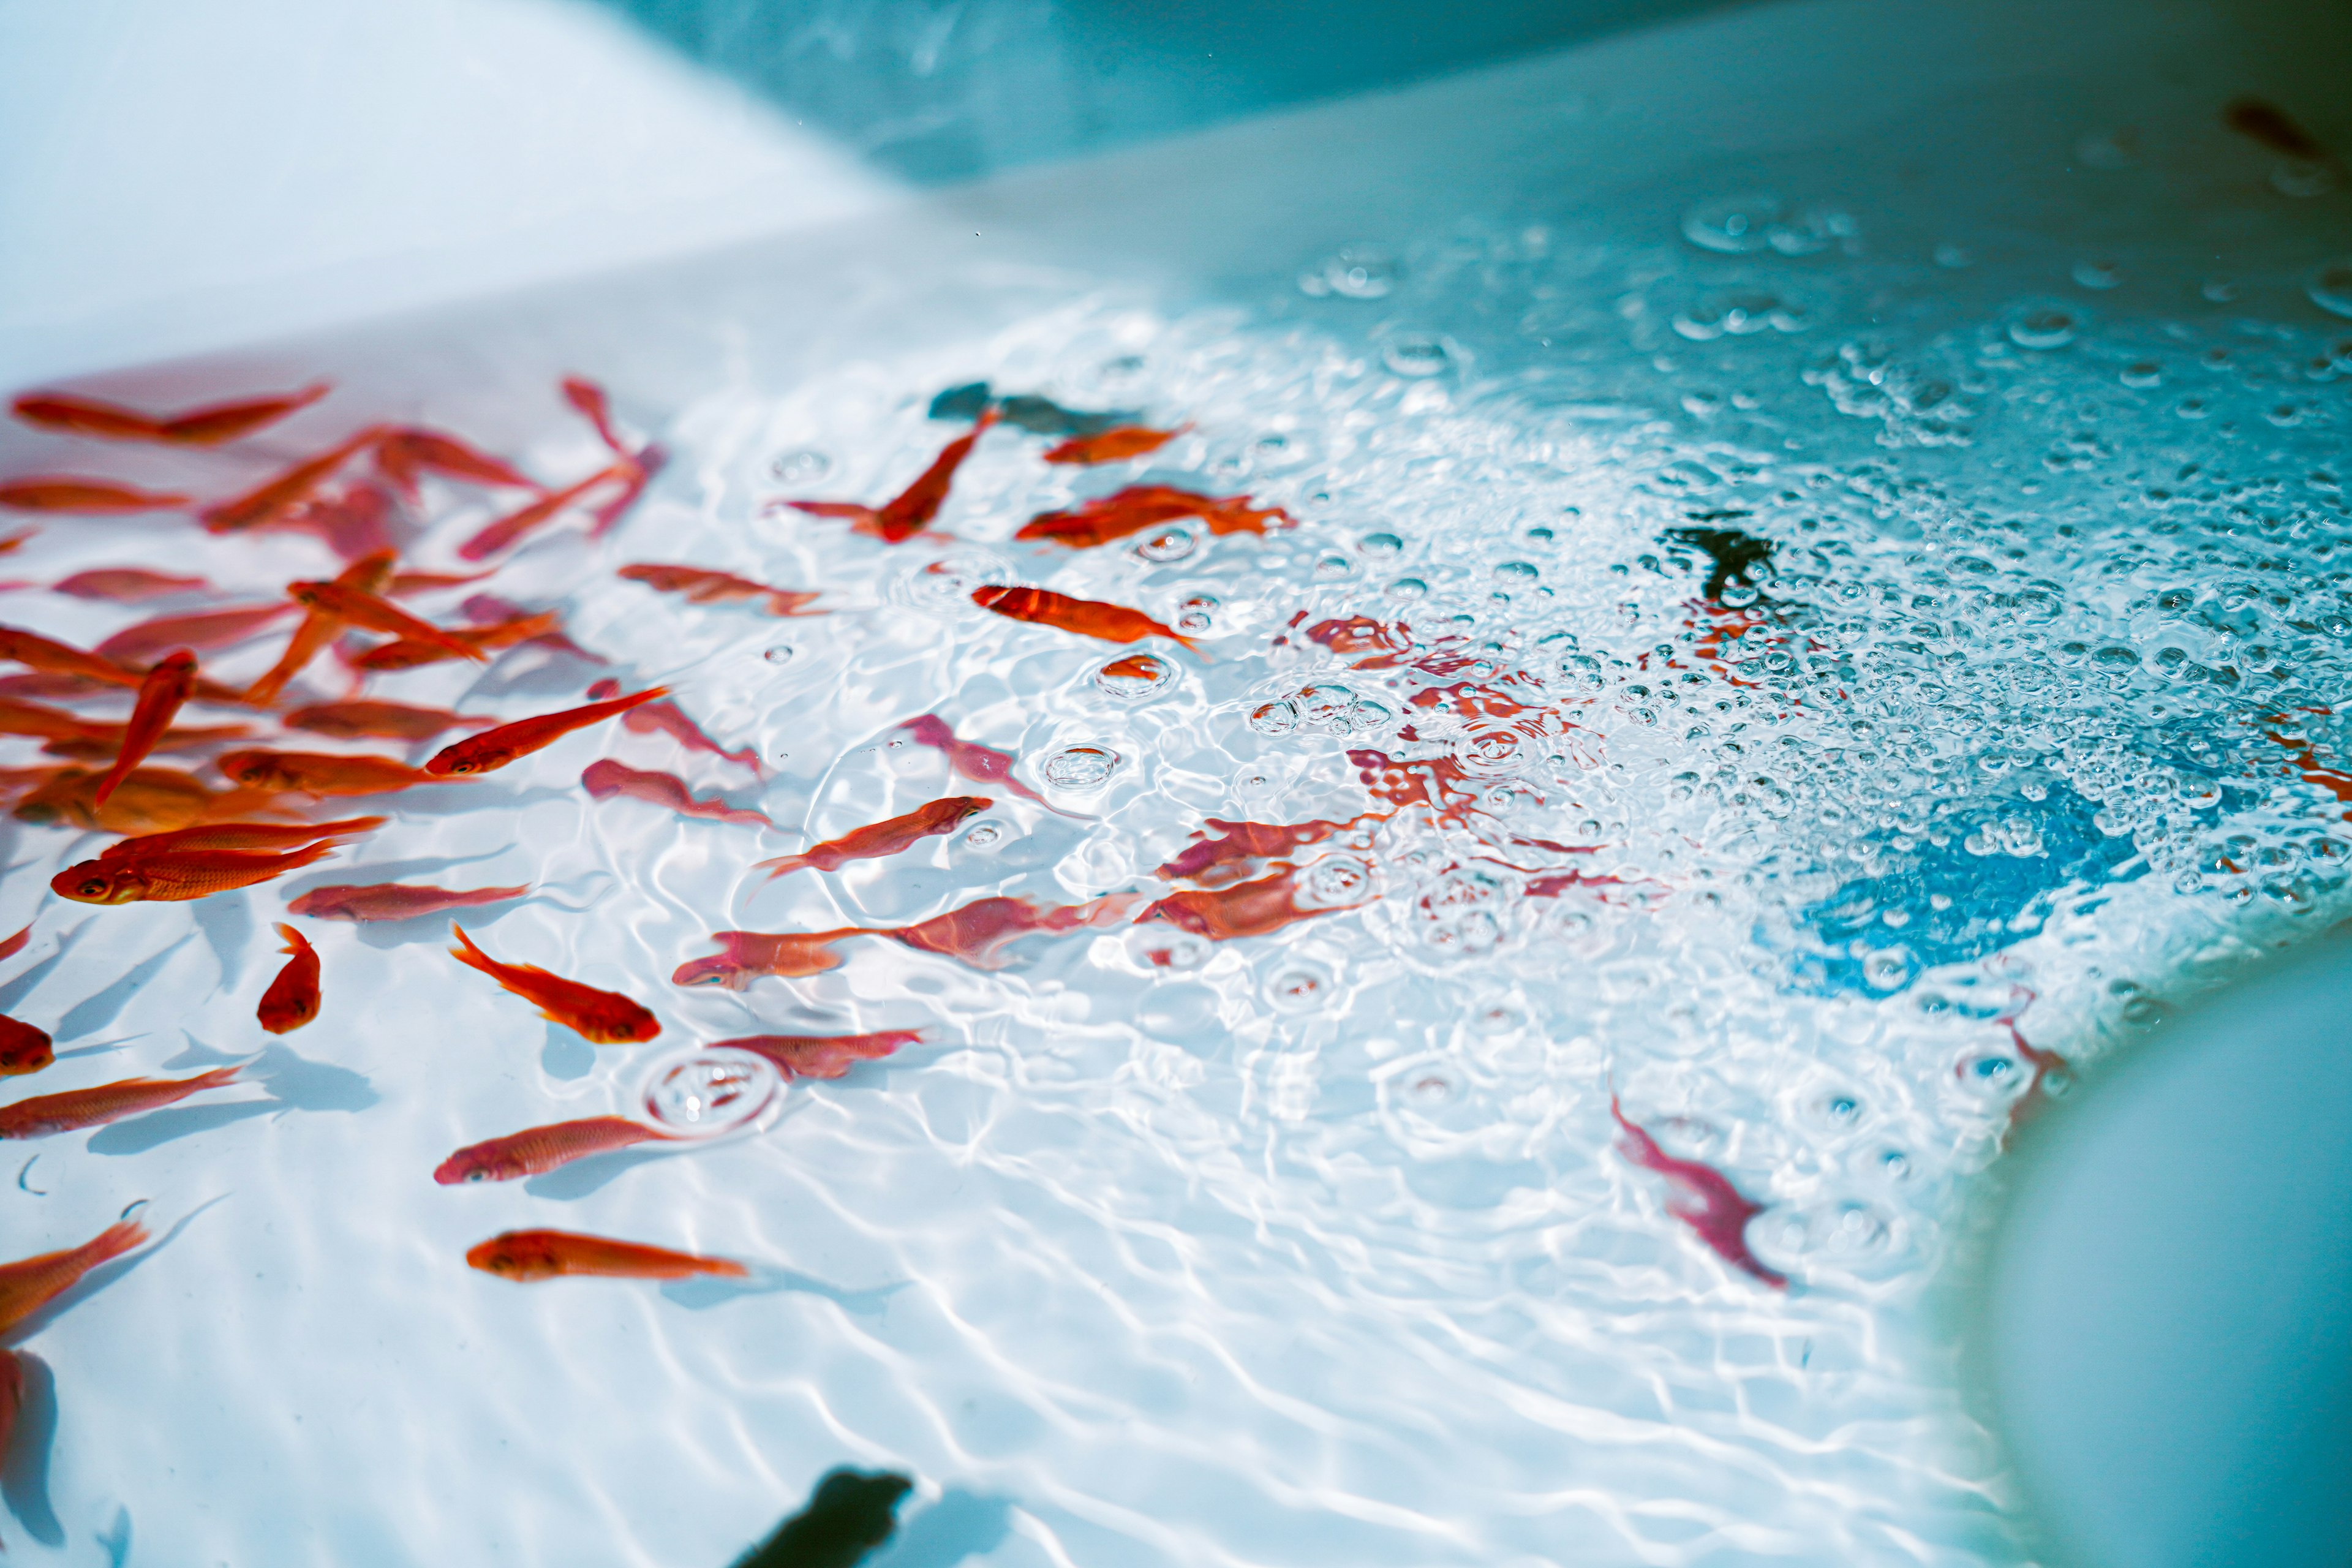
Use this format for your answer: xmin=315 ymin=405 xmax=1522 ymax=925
xmin=0 ymin=49 xmax=2352 ymax=1568
